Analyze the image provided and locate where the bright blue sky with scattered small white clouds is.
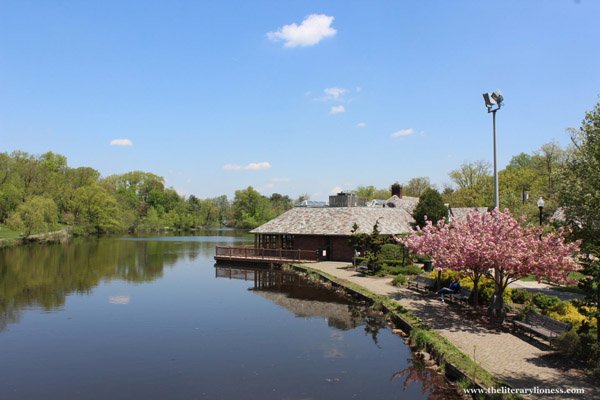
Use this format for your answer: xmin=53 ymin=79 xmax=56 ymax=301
xmin=0 ymin=0 xmax=600 ymax=199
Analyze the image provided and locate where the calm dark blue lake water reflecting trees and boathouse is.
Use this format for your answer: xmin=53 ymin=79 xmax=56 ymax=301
xmin=0 ymin=230 xmax=458 ymax=399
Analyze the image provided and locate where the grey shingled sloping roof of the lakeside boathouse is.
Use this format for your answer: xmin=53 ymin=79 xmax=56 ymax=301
xmin=250 ymin=207 xmax=414 ymax=236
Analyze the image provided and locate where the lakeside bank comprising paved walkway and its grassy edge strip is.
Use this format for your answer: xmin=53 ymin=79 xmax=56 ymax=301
xmin=294 ymin=262 xmax=600 ymax=398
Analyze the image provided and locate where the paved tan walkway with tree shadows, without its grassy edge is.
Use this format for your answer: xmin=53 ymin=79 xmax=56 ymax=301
xmin=306 ymin=262 xmax=600 ymax=399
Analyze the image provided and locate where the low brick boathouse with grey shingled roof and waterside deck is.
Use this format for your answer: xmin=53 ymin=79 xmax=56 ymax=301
xmin=215 ymin=185 xmax=418 ymax=264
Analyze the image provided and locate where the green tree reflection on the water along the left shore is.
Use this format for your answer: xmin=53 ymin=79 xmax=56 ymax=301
xmin=0 ymin=239 xmax=205 ymax=331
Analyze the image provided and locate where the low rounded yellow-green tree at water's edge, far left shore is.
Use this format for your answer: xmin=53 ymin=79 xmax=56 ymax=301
xmin=7 ymin=196 xmax=58 ymax=237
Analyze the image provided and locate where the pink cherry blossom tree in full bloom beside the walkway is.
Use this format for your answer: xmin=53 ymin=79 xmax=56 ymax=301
xmin=404 ymin=209 xmax=580 ymax=316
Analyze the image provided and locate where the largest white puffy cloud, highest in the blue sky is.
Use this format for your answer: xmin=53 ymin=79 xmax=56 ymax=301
xmin=267 ymin=14 xmax=337 ymax=47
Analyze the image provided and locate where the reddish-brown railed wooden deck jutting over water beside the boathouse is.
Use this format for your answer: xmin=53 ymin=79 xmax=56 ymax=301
xmin=215 ymin=246 xmax=318 ymax=264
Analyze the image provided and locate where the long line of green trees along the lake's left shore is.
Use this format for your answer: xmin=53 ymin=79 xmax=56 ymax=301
xmin=0 ymin=151 xmax=293 ymax=236
